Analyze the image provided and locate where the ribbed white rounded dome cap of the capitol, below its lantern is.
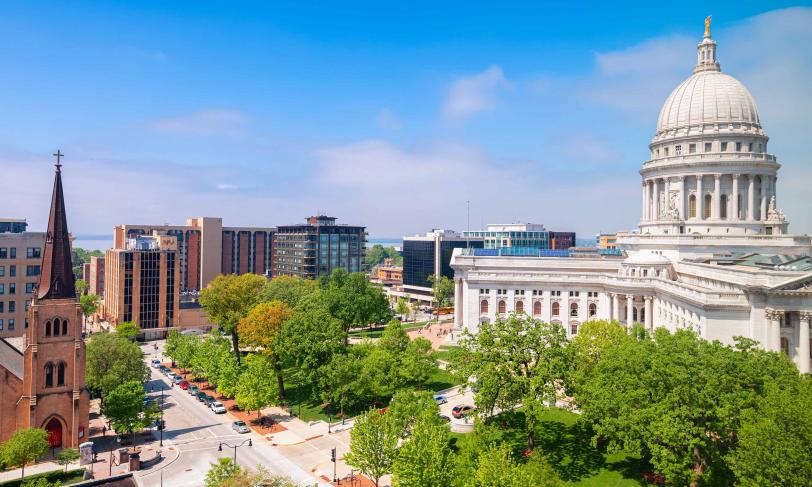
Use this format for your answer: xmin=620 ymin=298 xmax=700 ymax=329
xmin=657 ymin=70 xmax=761 ymax=135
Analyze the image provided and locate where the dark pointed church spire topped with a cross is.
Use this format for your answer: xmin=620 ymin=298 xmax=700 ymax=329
xmin=37 ymin=151 xmax=76 ymax=299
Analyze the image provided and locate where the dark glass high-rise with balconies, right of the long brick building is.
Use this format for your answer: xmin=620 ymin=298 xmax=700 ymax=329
xmin=273 ymin=215 xmax=366 ymax=278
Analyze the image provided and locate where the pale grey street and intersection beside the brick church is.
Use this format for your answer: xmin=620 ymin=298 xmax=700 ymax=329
xmin=138 ymin=342 xmax=326 ymax=487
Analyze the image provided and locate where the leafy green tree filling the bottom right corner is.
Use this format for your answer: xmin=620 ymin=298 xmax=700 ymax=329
xmin=728 ymin=376 xmax=812 ymax=487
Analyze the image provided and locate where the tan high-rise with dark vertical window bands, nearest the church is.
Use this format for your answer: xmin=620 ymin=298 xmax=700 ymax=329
xmin=103 ymin=232 xmax=180 ymax=338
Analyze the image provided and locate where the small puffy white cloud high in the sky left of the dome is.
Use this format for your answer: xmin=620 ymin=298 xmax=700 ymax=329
xmin=443 ymin=65 xmax=513 ymax=121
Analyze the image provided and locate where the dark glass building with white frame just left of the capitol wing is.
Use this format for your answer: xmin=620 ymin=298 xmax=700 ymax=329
xmin=400 ymin=230 xmax=485 ymax=302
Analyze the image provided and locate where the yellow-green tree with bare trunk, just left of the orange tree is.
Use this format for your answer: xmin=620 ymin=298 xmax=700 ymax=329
xmin=200 ymin=274 xmax=267 ymax=364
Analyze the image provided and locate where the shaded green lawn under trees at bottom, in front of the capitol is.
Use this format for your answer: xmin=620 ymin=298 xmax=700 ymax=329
xmin=451 ymin=409 xmax=649 ymax=487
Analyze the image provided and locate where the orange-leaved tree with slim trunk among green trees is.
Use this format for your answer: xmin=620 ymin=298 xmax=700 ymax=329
xmin=237 ymin=301 xmax=293 ymax=400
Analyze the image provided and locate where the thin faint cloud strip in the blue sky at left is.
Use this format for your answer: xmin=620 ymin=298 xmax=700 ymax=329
xmin=149 ymin=109 xmax=248 ymax=137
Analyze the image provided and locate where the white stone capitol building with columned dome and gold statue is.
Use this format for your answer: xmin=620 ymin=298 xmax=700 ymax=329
xmin=451 ymin=21 xmax=812 ymax=373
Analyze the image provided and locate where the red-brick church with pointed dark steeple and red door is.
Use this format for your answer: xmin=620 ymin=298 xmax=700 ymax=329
xmin=0 ymin=160 xmax=89 ymax=448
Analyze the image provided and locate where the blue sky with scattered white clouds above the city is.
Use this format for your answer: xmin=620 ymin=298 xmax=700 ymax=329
xmin=0 ymin=0 xmax=812 ymax=238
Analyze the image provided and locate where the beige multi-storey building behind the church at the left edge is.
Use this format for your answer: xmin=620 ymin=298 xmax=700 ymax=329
xmin=0 ymin=219 xmax=45 ymax=337
